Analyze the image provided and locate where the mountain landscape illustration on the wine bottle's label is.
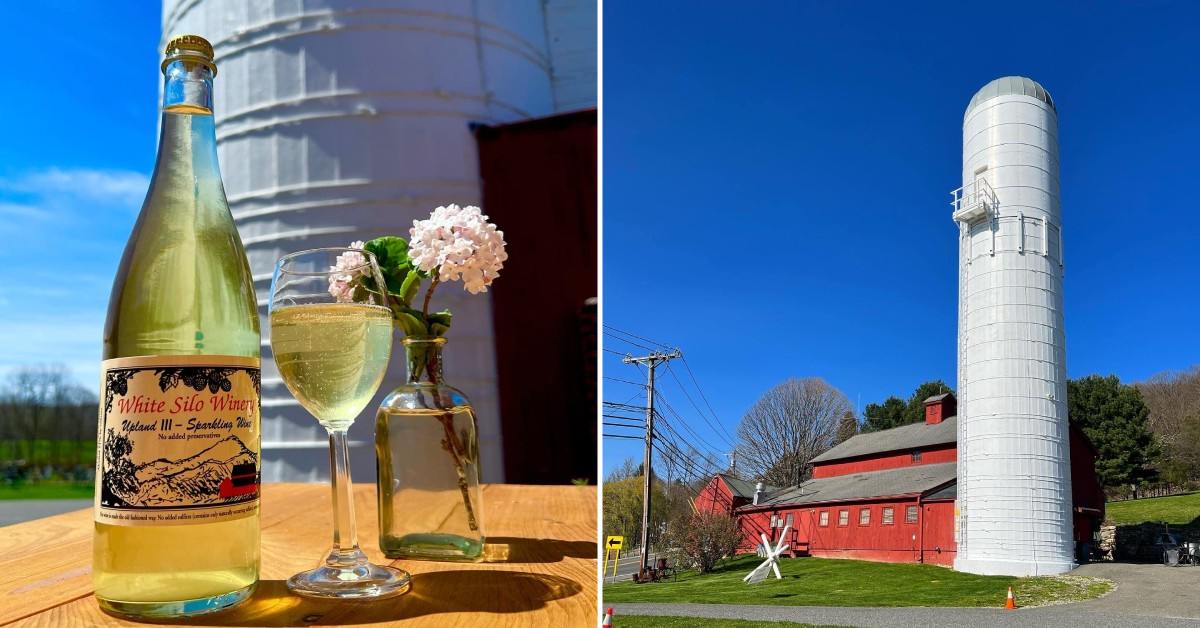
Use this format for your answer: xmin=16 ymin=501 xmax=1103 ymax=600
xmin=104 ymin=435 xmax=258 ymax=508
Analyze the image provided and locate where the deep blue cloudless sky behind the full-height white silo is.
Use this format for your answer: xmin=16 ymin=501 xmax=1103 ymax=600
xmin=604 ymin=1 xmax=1200 ymax=473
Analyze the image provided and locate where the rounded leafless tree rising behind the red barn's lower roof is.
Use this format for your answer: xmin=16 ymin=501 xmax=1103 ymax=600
xmin=737 ymin=377 xmax=851 ymax=486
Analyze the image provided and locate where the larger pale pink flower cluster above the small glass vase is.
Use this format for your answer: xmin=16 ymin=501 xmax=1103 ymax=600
xmin=408 ymin=204 xmax=509 ymax=294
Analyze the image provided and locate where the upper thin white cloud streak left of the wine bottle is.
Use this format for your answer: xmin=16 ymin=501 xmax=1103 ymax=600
xmin=0 ymin=168 xmax=150 ymax=208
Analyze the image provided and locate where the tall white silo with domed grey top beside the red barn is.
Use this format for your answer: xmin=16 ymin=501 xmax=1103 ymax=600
xmin=953 ymin=77 xmax=1074 ymax=575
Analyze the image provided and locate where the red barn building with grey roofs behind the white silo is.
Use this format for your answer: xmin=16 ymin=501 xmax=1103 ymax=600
xmin=695 ymin=393 xmax=1104 ymax=566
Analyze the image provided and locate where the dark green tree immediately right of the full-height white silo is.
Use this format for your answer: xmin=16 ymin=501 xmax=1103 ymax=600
xmin=1067 ymin=375 xmax=1159 ymax=486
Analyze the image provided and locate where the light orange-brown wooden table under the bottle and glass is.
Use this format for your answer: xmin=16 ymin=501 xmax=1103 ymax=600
xmin=0 ymin=484 xmax=598 ymax=628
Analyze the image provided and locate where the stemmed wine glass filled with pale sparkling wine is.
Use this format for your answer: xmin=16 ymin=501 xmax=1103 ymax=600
xmin=269 ymin=249 xmax=410 ymax=598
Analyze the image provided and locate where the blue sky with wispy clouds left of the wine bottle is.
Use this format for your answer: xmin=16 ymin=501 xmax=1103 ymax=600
xmin=0 ymin=1 xmax=161 ymax=390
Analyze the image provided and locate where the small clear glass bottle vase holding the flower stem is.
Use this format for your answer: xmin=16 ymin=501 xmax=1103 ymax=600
xmin=376 ymin=337 xmax=484 ymax=562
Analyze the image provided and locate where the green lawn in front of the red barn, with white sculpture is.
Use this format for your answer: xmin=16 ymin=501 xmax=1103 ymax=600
xmin=604 ymin=556 xmax=1112 ymax=606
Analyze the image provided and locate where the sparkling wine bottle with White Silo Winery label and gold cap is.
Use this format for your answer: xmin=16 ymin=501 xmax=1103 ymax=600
xmin=92 ymin=35 xmax=262 ymax=617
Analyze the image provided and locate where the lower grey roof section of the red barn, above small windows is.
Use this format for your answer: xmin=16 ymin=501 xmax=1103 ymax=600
xmin=739 ymin=462 xmax=958 ymax=510
